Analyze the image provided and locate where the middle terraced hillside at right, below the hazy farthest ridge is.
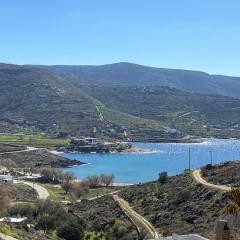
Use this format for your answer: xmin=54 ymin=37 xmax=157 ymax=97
xmin=84 ymin=85 xmax=240 ymax=137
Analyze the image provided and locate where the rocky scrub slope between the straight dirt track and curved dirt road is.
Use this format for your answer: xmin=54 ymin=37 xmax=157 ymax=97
xmin=120 ymin=172 xmax=228 ymax=236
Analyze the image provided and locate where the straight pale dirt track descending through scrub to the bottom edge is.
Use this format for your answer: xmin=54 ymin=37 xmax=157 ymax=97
xmin=113 ymin=195 xmax=159 ymax=239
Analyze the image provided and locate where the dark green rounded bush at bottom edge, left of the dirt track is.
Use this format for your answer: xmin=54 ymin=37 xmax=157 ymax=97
xmin=57 ymin=222 xmax=84 ymax=240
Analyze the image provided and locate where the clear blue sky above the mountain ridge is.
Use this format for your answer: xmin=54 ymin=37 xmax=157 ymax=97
xmin=0 ymin=0 xmax=240 ymax=76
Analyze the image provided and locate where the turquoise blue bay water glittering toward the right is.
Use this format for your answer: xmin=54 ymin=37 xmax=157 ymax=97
xmin=60 ymin=139 xmax=240 ymax=183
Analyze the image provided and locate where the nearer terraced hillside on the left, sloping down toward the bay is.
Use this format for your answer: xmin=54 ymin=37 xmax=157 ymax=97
xmin=0 ymin=64 xmax=184 ymax=142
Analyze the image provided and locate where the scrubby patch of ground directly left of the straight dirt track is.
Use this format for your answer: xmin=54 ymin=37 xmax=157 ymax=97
xmin=70 ymin=196 xmax=138 ymax=240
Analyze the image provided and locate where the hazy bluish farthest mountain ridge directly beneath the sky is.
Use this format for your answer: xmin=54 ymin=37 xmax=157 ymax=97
xmin=41 ymin=63 xmax=240 ymax=97
